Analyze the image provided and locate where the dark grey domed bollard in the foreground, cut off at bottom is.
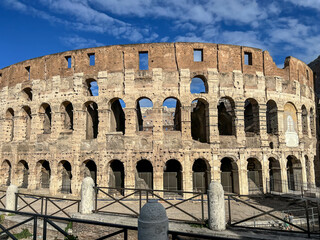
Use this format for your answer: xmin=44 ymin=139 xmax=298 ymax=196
xmin=138 ymin=200 xmax=169 ymax=240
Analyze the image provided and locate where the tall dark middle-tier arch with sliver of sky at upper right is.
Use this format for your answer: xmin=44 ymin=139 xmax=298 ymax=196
xmin=110 ymin=98 xmax=126 ymax=134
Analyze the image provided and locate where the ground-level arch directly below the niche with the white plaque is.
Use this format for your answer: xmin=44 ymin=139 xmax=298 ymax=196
xmin=287 ymin=156 xmax=302 ymax=191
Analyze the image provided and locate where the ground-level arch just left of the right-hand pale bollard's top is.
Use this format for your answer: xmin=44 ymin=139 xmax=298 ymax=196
xmin=192 ymin=158 xmax=211 ymax=193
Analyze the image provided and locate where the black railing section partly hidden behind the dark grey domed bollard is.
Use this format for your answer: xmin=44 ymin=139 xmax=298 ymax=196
xmin=94 ymin=187 xmax=207 ymax=224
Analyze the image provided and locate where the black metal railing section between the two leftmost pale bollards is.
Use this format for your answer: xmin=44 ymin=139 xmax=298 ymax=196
xmin=16 ymin=193 xmax=80 ymax=218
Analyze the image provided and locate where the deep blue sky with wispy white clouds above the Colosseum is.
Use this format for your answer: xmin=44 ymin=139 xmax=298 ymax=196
xmin=0 ymin=0 xmax=320 ymax=68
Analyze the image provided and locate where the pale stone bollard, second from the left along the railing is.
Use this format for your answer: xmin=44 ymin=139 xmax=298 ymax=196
xmin=80 ymin=177 xmax=95 ymax=214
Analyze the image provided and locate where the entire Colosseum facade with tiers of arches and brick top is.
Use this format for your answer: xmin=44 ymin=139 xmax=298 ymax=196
xmin=0 ymin=43 xmax=316 ymax=195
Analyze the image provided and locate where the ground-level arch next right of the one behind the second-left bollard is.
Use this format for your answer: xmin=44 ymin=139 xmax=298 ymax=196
xmin=109 ymin=160 xmax=124 ymax=195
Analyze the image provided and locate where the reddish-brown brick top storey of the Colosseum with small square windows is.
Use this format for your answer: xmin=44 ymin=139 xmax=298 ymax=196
xmin=0 ymin=43 xmax=313 ymax=88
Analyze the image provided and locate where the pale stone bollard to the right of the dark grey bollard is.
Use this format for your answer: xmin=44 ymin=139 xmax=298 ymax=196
xmin=208 ymin=181 xmax=226 ymax=231
